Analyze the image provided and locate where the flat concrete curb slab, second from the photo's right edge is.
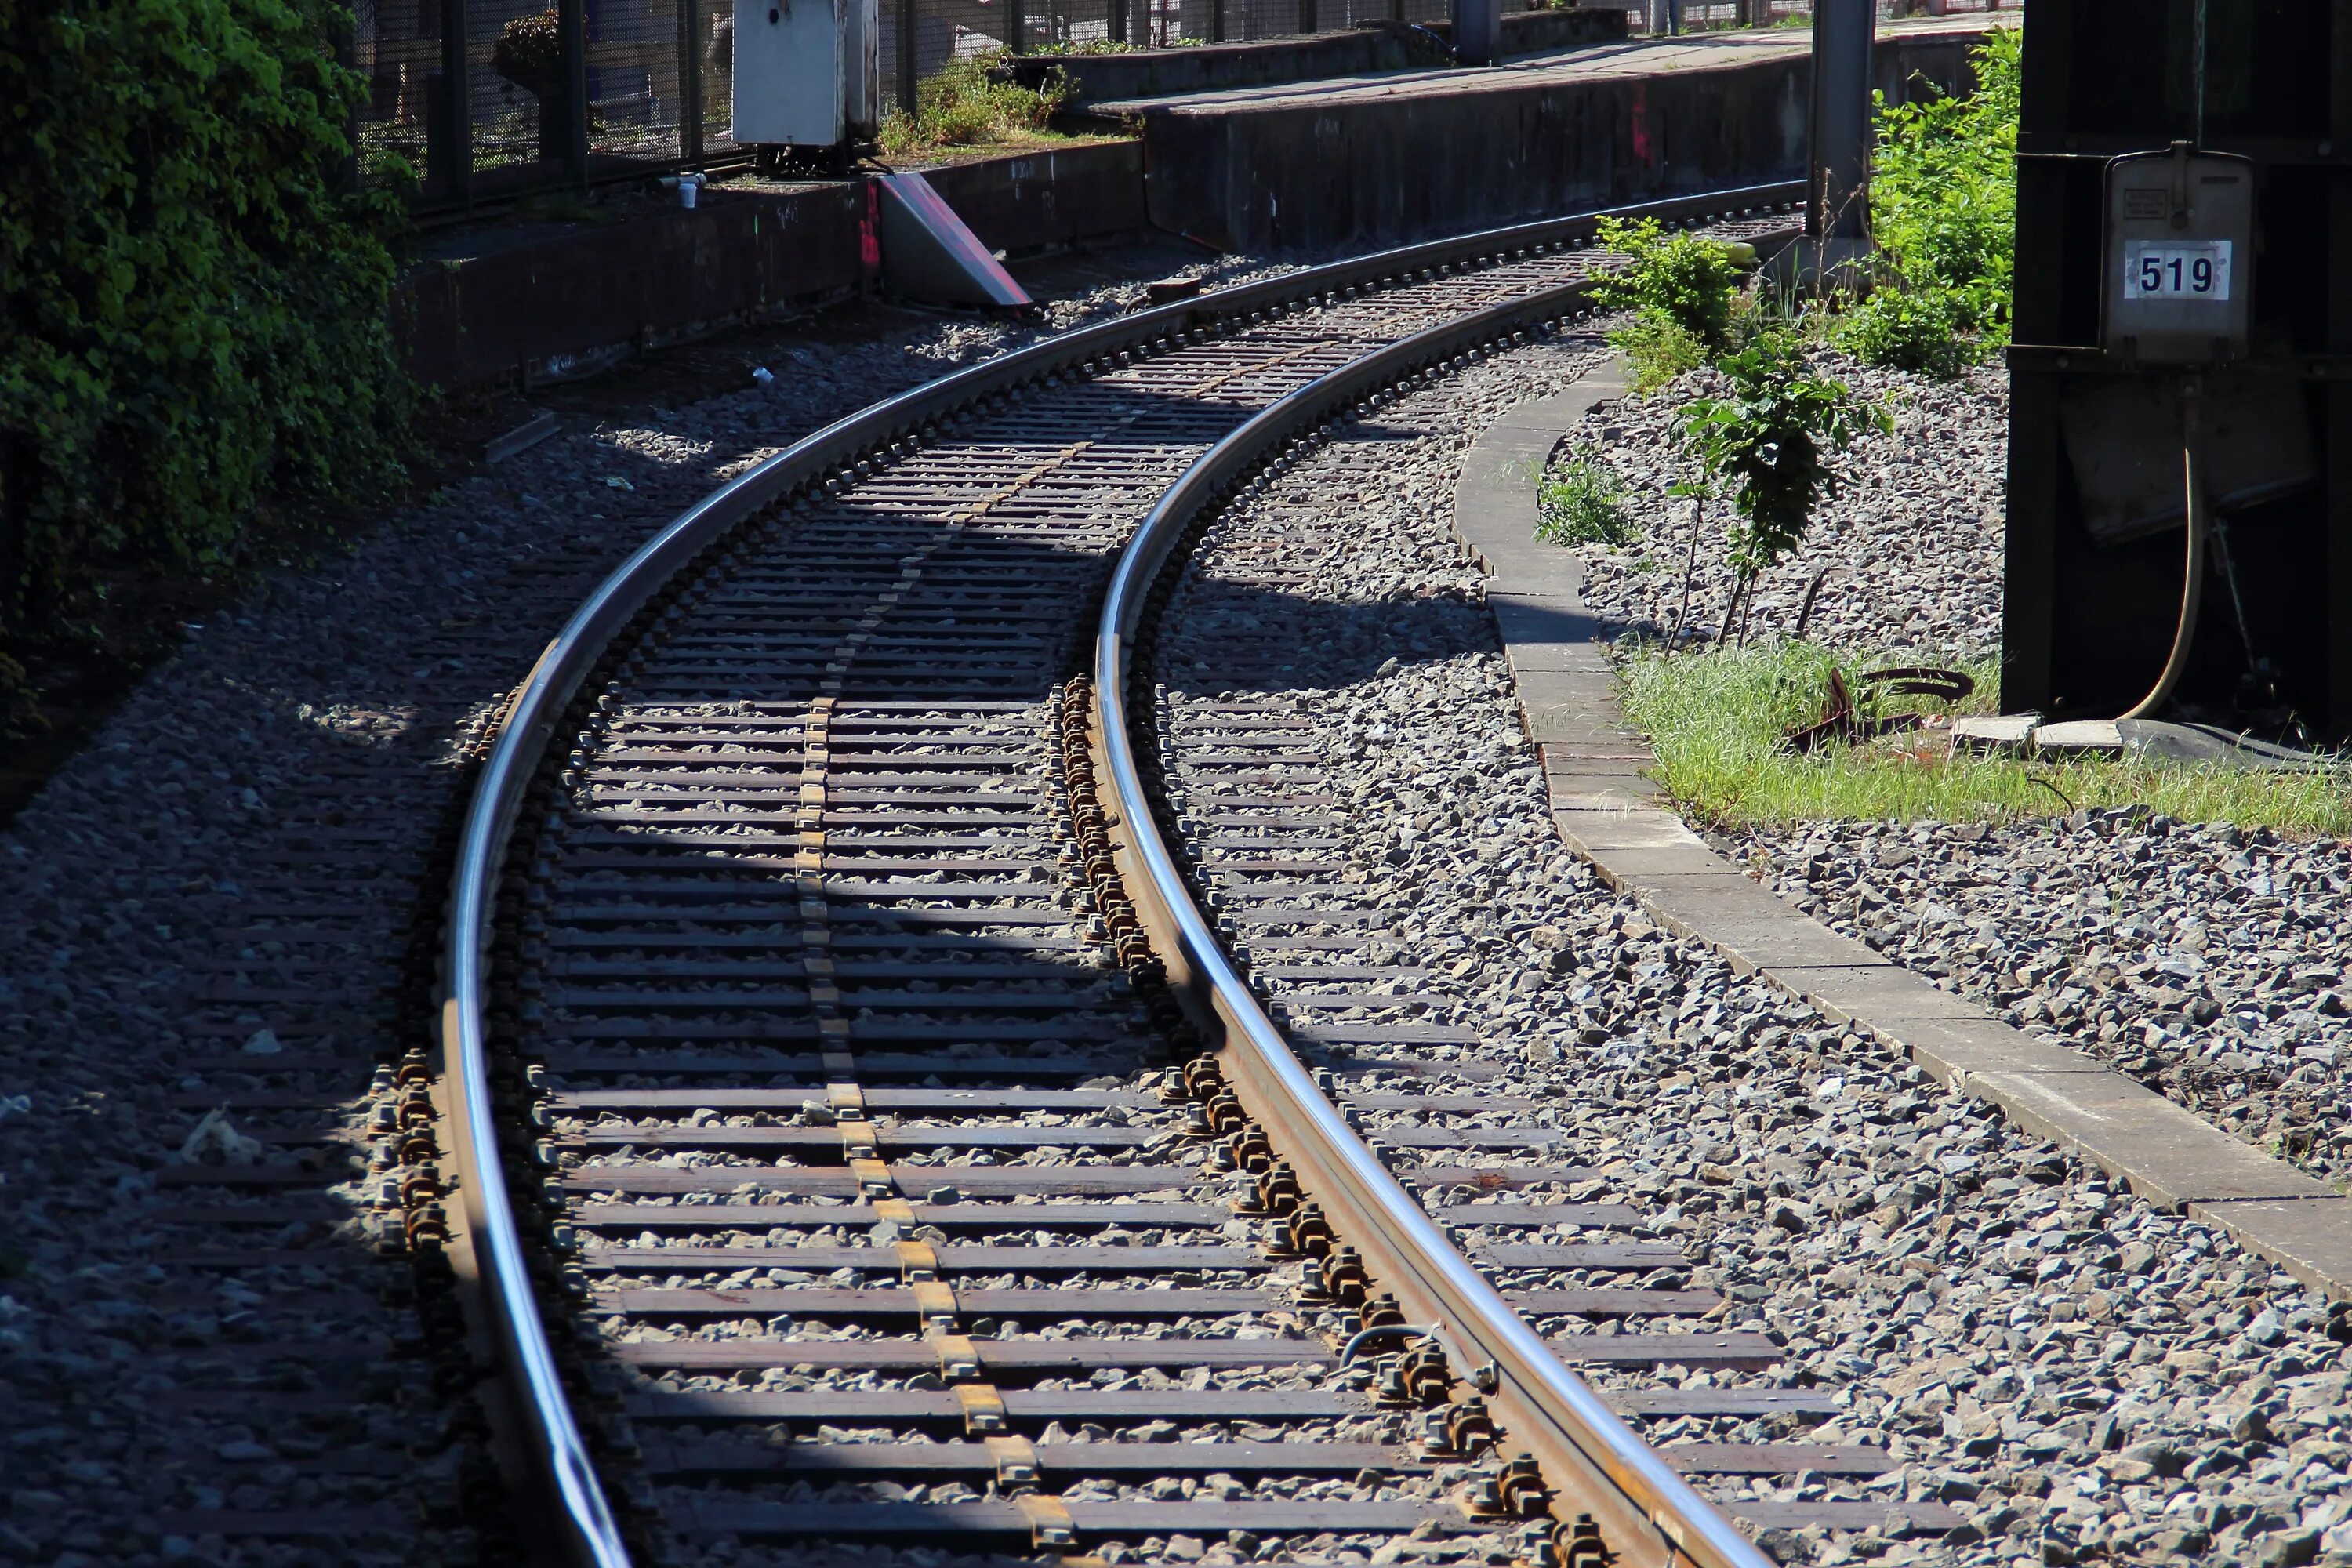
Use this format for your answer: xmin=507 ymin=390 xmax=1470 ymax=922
xmin=1966 ymin=1072 xmax=2333 ymax=1210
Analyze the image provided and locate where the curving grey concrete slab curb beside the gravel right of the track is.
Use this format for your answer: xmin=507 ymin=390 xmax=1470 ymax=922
xmin=1454 ymin=367 xmax=2352 ymax=1300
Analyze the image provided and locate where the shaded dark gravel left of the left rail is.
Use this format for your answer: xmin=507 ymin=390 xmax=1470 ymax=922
xmin=0 ymin=263 xmax=1251 ymax=1568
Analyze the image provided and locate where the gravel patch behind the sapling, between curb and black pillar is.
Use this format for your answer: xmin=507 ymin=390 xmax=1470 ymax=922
xmin=1562 ymin=350 xmax=2009 ymax=654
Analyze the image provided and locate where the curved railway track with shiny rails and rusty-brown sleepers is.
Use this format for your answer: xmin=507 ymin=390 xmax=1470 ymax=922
xmin=428 ymin=188 xmax=1947 ymax=1568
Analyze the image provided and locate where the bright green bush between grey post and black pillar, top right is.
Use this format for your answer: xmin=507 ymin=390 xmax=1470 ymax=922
xmin=1870 ymin=28 xmax=2023 ymax=339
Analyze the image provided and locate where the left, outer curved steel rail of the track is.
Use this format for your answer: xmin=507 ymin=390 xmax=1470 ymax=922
xmin=440 ymin=181 xmax=1804 ymax=1568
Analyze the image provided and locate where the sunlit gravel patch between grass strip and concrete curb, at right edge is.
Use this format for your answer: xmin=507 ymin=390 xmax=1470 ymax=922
xmin=1717 ymin=811 xmax=2352 ymax=1182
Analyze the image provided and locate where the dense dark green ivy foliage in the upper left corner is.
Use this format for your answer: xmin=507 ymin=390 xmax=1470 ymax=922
xmin=0 ymin=0 xmax=414 ymax=675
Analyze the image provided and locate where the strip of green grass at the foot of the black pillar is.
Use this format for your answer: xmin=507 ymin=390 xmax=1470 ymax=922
xmin=1621 ymin=642 xmax=2352 ymax=834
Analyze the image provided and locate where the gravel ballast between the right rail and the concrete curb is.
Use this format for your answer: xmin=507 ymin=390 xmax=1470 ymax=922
xmin=1143 ymin=348 xmax=2352 ymax=1563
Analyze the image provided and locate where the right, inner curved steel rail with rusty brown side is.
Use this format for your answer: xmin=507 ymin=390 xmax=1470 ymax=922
xmin=1094 ymin=282 xmax=1771 ymax=1568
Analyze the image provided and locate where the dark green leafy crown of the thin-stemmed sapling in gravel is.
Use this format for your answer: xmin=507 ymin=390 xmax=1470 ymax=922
xmin=1682 ymin=329 xmax=1889 ymax=583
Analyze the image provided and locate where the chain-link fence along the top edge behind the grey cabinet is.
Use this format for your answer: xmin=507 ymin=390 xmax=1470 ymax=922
xmin=353 ymin=0 xmax=2023 ymax=212
